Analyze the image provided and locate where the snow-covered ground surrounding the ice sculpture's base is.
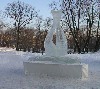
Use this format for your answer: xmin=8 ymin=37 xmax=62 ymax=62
xmin=0 ymin=48 xmax=100 ymax=89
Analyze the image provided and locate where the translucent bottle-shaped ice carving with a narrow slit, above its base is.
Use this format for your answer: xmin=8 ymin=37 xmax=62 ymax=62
xmin=45 ymin=10 xmax=67 ymax=57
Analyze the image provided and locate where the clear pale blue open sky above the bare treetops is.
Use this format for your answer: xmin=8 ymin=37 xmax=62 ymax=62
xmin=0 ymin=0 xmax=61 ymax=18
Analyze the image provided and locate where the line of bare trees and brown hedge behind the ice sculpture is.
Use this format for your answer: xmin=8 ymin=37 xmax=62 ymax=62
xmin=0 ymin=0 xmax=100 ymax=53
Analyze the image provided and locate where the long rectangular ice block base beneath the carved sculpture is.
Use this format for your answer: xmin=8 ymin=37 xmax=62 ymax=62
xmin=23 ymin=61 xmax=88 ymax=79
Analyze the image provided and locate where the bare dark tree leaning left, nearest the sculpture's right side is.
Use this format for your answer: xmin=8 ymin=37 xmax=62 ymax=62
xmin=62 ymin=0 xmax=81 ymax=53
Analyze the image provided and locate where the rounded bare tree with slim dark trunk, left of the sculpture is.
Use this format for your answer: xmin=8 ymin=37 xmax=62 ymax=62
xmin=5 ymin=1 xmax=37 ymax=50
